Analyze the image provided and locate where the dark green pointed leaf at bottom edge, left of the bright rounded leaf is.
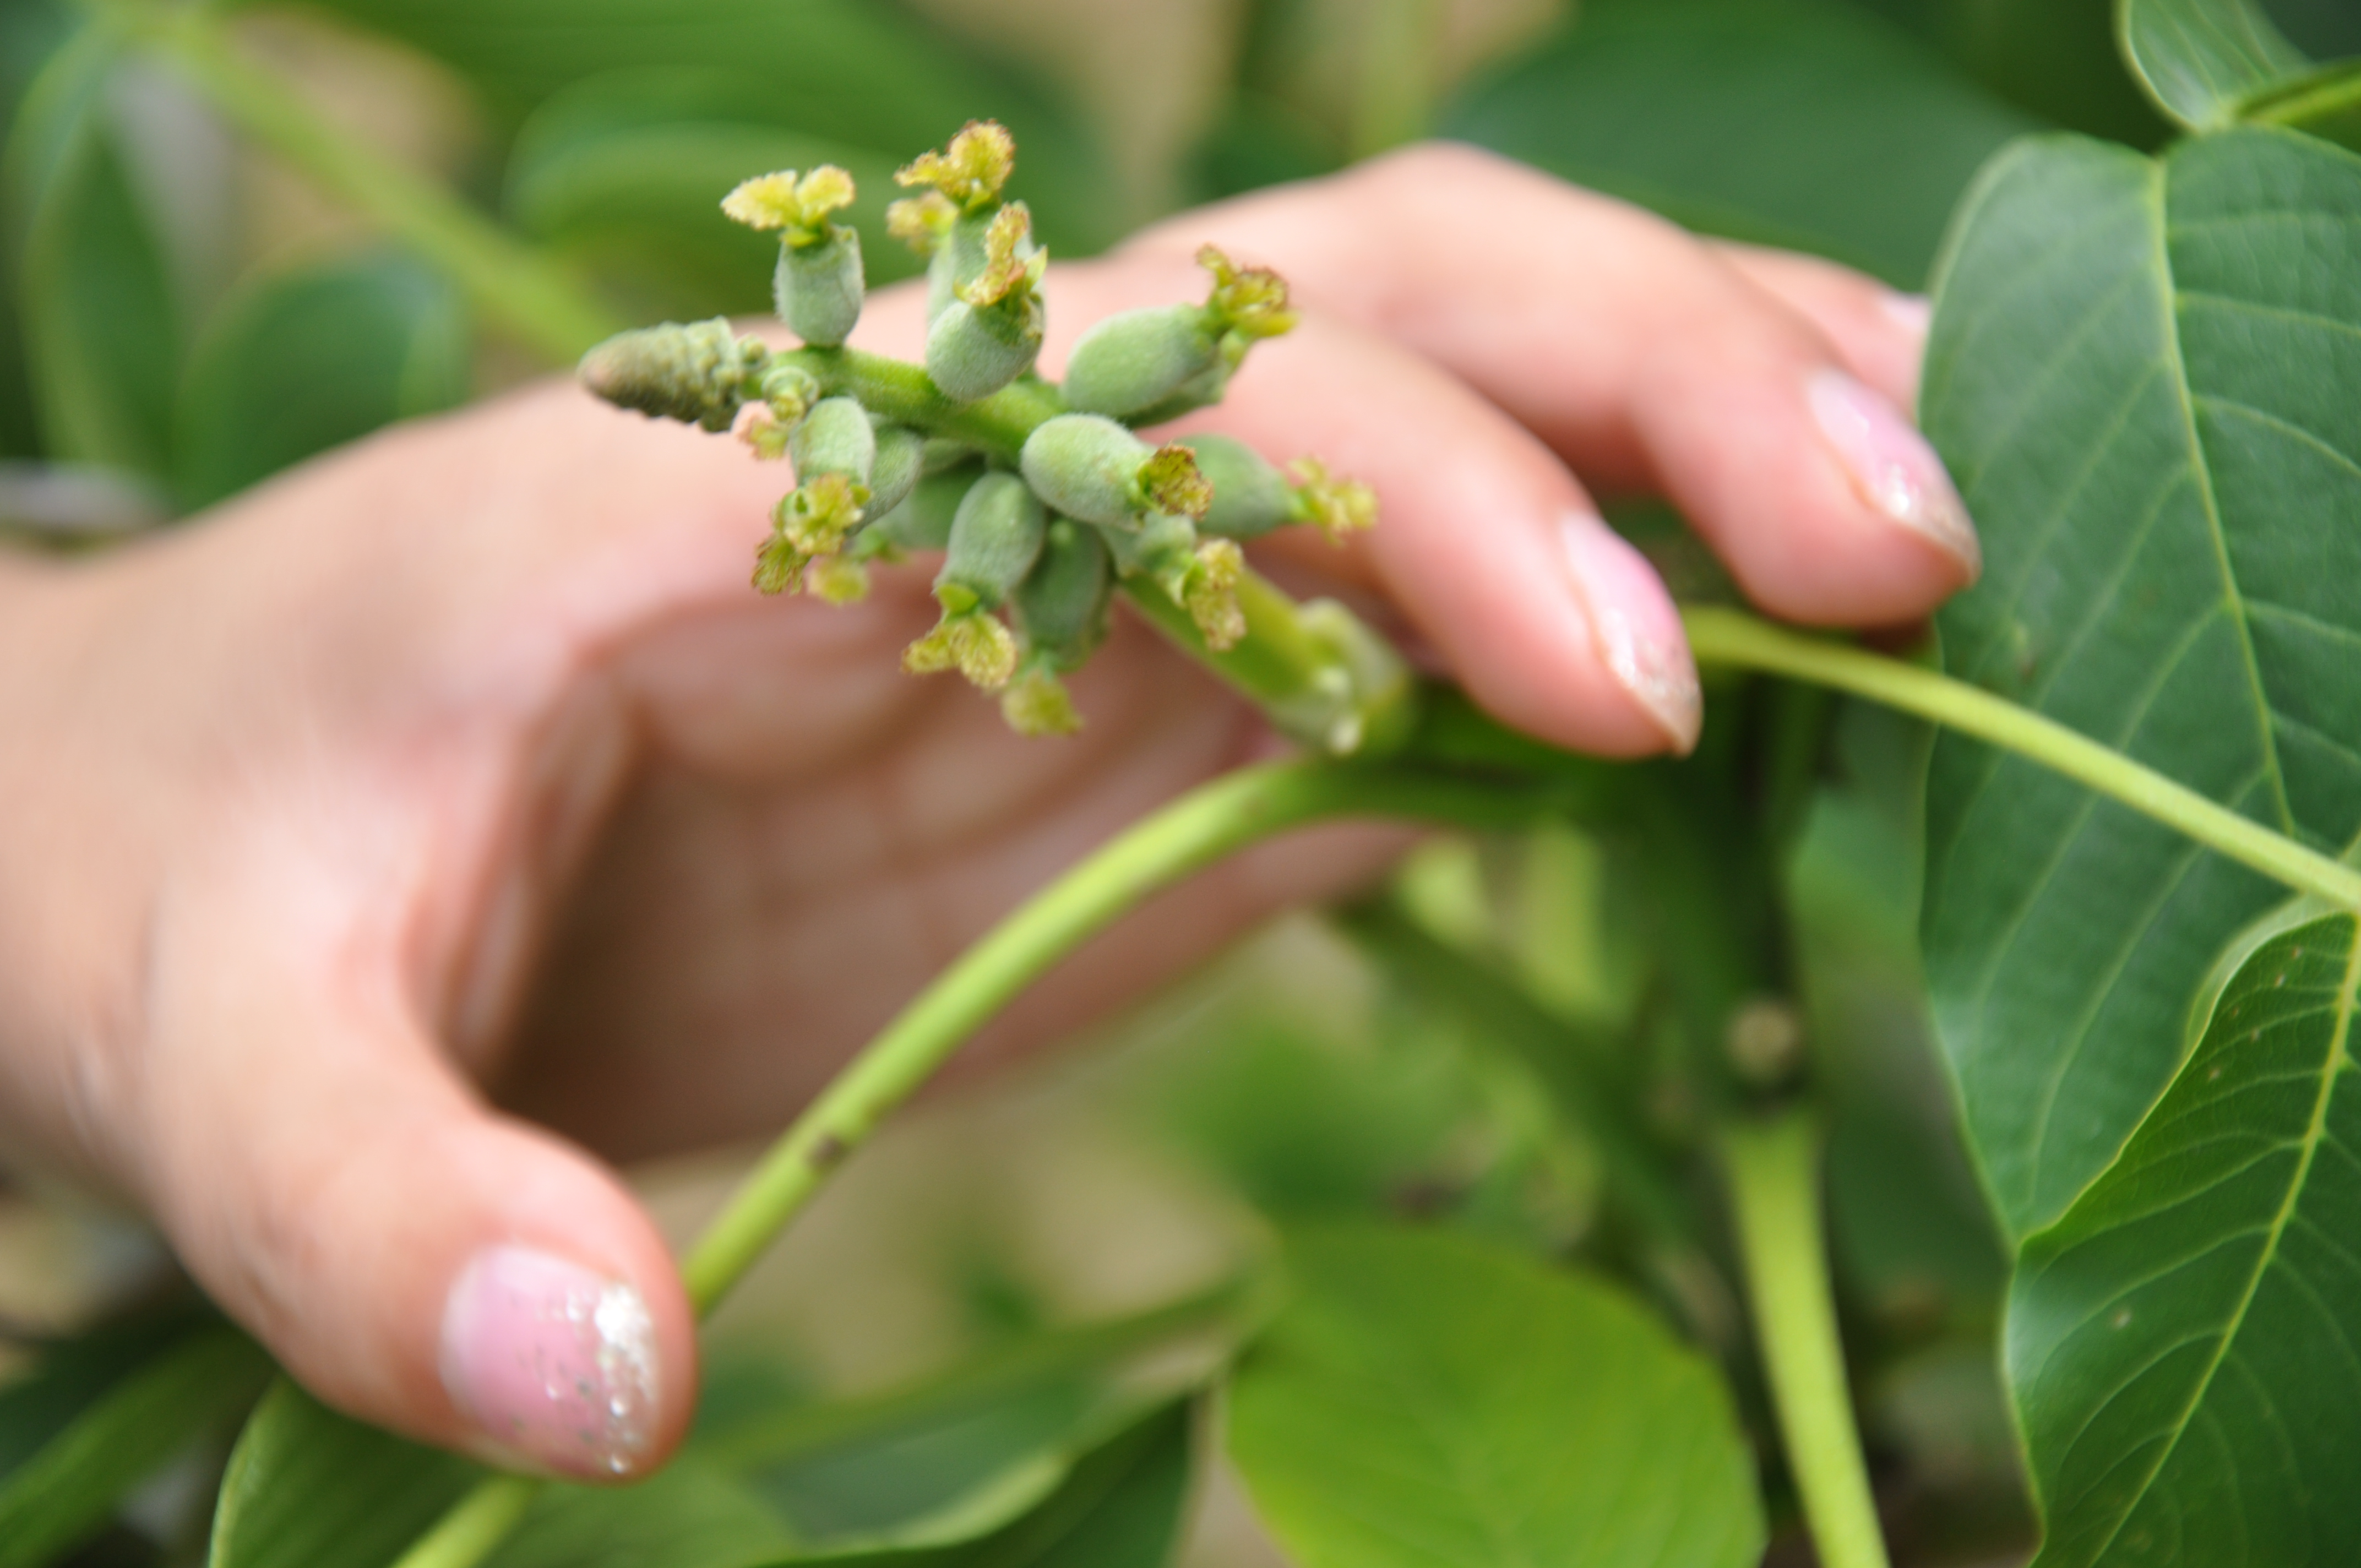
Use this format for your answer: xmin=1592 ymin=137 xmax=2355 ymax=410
xmin=784 ymin=1400 xmax=1197 ymax=1568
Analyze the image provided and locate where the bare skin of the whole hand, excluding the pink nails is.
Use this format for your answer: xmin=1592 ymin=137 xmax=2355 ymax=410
xmin=0 ymin=149 xmax=1971 ymax=1457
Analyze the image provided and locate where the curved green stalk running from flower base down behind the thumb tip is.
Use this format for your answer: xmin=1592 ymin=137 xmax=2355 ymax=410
xmin=394 ymin=763 xmax=1544 ymax=1568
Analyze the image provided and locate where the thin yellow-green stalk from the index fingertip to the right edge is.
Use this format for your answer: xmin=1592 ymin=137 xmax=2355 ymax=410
xmin=1683 ymin=609 xmax=2361 ymax=909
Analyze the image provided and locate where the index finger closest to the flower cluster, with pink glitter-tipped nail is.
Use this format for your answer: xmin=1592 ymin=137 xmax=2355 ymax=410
xmin=1063 ymin=267 xmax=1700 ymax=756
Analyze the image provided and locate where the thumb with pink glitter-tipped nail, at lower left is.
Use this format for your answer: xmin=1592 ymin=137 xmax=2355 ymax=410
xmin=142 ymin=888 xmax=697 ymax=1478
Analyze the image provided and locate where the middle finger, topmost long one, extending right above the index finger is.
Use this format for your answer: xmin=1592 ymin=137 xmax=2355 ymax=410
xmin=1140 ymin=146 xmax=1978 ymax=623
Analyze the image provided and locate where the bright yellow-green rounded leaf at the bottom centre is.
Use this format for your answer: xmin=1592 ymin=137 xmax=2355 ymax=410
xmin=1228 ymin=1231 xmax=1764 ymax=1568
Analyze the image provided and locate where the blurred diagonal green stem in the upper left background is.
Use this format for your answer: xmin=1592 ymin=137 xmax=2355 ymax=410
xmin=106 ymin=0 xmax=621 ymax=364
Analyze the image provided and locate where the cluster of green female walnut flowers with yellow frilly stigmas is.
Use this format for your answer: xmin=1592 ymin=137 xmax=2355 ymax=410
xmin=583 ymin=123 xmax=1379 ymax=751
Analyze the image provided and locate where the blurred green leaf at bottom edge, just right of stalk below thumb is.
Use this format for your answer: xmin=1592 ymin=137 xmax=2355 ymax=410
xmin=486 ymin=1455 xmax=796 ymax=1568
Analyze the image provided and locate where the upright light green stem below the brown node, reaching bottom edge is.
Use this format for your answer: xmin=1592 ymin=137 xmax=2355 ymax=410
xmin=1721 ymin=1108 xmax=1886 ymax=1568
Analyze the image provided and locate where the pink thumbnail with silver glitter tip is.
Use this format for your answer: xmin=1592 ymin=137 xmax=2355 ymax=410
xmin=442 ymin=1247 xmax=656 ymax=1476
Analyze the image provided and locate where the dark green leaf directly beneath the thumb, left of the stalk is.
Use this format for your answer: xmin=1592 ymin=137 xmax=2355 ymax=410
xmin=208 ymin=1379 xmax=486 ymax=1568
